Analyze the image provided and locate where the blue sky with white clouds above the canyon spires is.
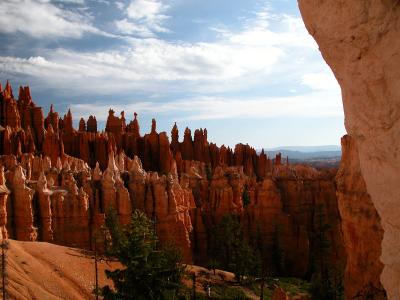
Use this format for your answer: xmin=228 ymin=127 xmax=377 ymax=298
xmin=0 ymin=0 xmax=345 ymax=149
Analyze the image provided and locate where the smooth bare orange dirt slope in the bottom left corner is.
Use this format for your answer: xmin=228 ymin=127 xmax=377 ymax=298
xmin=0 ymin=240 xmax=117 ymax=300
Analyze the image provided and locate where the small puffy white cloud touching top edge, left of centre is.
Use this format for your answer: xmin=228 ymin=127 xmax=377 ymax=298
xmin=115 ymin=0 xmax=169 ymax=37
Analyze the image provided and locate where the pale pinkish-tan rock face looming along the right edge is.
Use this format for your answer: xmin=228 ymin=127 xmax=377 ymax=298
xmin=299 ymin=0 xmax=400 ymax=299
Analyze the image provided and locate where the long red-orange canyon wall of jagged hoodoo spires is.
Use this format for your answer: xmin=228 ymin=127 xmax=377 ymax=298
xmin=0 ymin=83 xmax=345 ymax=276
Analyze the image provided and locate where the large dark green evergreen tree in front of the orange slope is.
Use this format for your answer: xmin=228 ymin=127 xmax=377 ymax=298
xmin=102 ymin=210 xmax=184 ymax=300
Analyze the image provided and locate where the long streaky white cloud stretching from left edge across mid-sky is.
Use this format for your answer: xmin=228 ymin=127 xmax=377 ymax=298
xmin=0 ymin=39 xmax=281 ymax=93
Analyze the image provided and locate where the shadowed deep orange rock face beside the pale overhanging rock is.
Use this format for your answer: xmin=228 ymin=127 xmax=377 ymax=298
xmin=336 ymin=135 xmax=386 ymax=299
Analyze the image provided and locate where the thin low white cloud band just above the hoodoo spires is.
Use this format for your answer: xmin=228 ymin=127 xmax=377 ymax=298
xmin=71 ymin=91 xmax=343 ymax=121
